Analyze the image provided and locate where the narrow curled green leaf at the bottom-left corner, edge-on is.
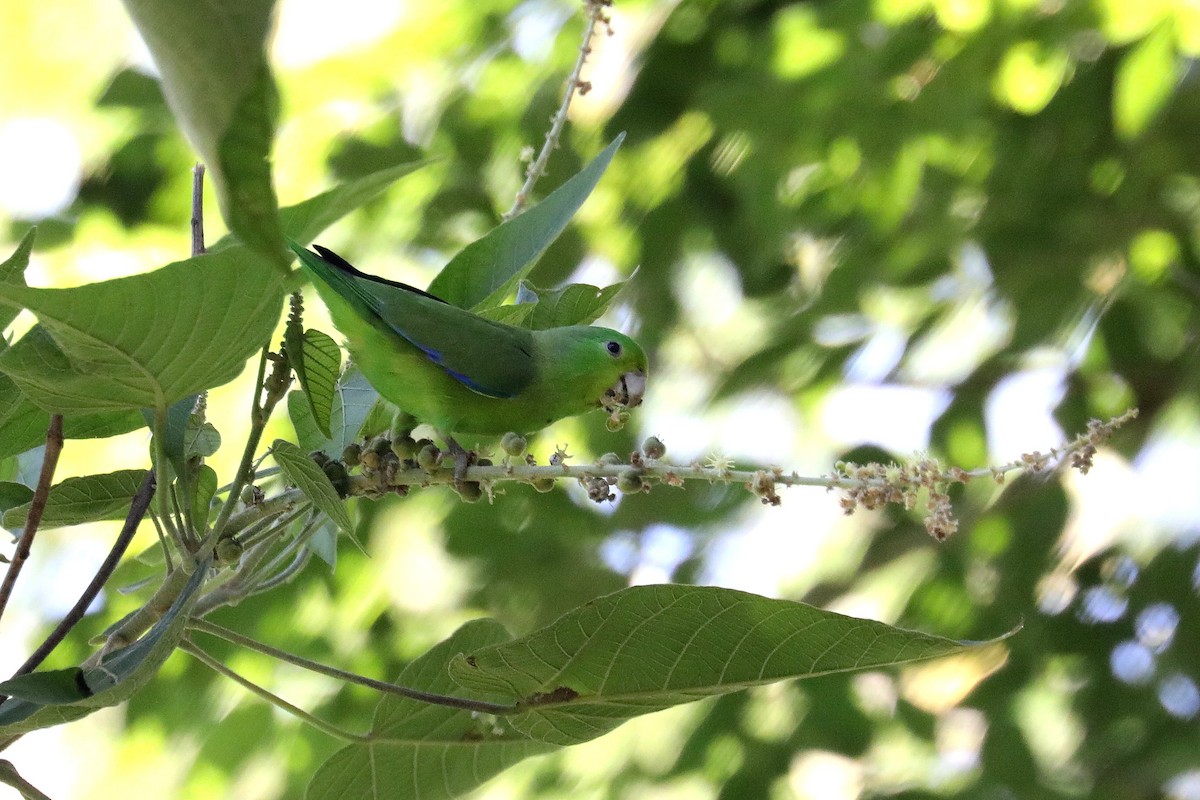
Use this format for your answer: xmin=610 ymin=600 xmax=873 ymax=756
xmin=0 ymin=563 xmax=209 ymax=736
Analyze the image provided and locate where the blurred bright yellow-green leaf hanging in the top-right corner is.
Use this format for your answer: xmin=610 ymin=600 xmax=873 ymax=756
xmin=1112 ymin=25 xmax=1181 ymax=139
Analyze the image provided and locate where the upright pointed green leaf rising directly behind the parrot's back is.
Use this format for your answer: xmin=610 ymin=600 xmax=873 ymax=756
xmin=430 ymin=133 xmax=625 ymax=311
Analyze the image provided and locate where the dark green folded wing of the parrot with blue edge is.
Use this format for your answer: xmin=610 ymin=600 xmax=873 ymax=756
xmin=292 ymin=243 xmax=536 ymax=398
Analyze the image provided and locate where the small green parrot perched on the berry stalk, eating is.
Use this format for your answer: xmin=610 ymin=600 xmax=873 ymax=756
xmin=289 ymin=242 xmax=648 ymax=462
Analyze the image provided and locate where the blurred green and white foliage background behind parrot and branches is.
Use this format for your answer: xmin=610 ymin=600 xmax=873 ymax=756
xmin=0 ymin=0 xmax=1200 ymax=800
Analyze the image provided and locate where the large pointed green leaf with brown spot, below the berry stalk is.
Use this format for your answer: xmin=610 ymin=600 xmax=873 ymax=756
xmin=450 ymin=585 xmax=993 ymax=745
